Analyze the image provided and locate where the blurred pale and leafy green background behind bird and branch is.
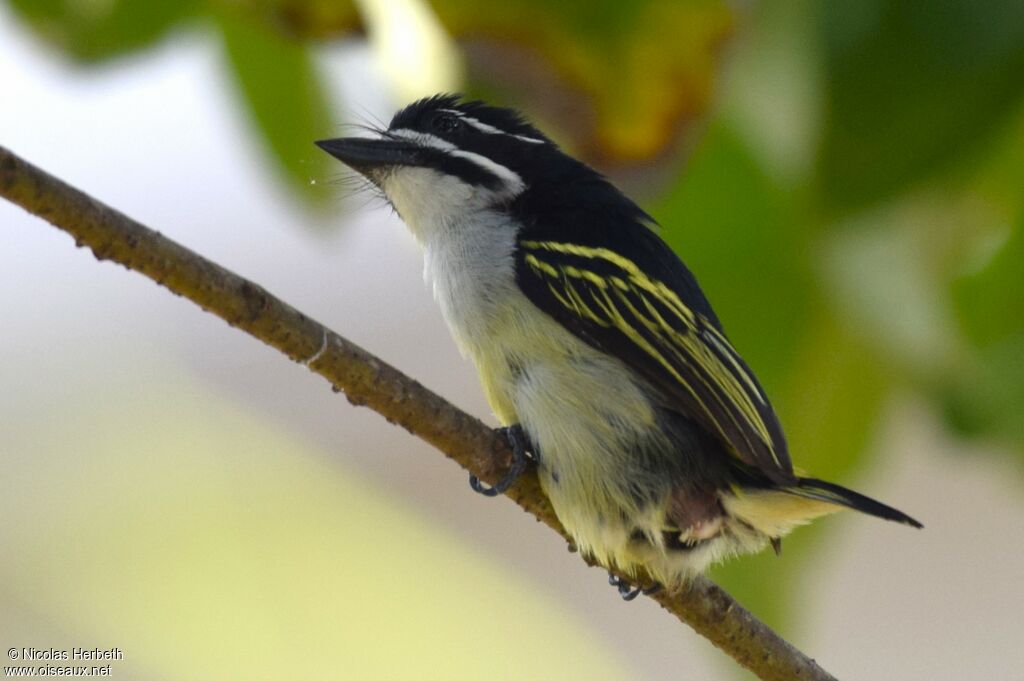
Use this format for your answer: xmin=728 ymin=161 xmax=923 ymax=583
xmin=0 ymin=0 xmax=1024 ymax=680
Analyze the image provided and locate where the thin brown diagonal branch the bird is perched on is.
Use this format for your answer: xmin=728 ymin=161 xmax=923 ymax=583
xmin=0 ymin=146 xmax=833 ymax=681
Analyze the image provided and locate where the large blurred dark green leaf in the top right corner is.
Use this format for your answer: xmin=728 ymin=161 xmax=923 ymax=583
xmin=819 ymin=0 xmax=1024 ymax=210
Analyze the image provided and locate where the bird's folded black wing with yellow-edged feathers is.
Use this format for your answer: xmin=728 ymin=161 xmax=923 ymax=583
xmin=516 ymin=232 xmax=795 ymax=483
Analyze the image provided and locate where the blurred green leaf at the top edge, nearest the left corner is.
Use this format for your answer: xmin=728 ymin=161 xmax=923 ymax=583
xmin=9 ymin=0 xmax=202 ymax=62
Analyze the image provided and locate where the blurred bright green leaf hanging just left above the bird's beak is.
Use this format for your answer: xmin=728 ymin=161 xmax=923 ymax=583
xmin=217 ymin=6 xmax=334 ymax=200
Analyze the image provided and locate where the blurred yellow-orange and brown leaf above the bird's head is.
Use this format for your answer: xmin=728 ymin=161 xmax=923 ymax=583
xmin=442 ymin=0 xmax=733 ymax=164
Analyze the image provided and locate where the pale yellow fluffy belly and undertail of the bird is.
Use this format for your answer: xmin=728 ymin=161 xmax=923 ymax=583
xmin=444 ymin=280 xmax=766 ymax=586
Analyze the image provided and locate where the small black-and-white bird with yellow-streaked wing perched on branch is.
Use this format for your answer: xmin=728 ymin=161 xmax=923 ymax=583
xmin=315 ymin=93 xmax=923 ymax=599
